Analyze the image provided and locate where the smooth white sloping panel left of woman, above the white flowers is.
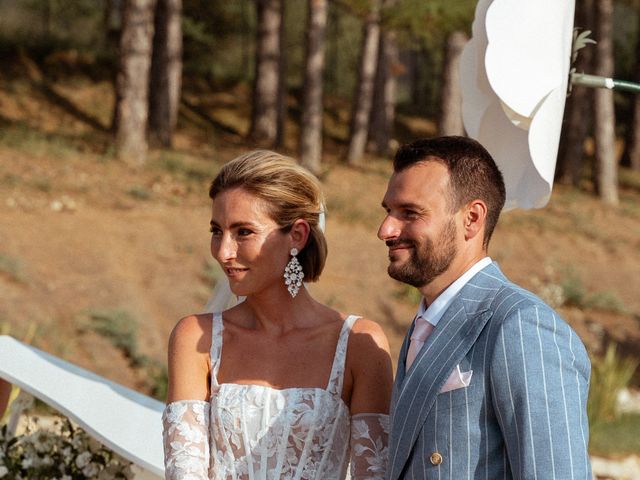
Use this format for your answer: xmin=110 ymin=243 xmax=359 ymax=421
xmin=0 ymin=335 xmax=164 ymax=479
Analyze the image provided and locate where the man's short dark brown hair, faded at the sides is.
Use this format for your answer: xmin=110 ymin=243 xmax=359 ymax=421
xmin=393 ymin=136 xmax=505 ymax=246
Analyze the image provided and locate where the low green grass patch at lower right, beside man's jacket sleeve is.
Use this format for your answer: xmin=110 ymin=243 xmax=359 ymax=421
xmin=589 ymin=413 xmax=640 ymax=457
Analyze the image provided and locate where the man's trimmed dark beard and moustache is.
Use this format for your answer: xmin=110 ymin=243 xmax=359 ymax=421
xmin=386 ymin=219 xmax=458 ymax=288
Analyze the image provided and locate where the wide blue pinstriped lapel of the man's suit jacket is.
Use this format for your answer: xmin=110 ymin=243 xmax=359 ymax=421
xmin=388 ymin=265 xmax=504 ymax=480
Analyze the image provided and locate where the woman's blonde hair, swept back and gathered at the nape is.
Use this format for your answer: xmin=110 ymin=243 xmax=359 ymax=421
xmin=209 ymin=150 xmax=327 ymax=282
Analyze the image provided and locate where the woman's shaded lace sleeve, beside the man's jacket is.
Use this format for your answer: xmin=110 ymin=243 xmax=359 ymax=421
xmin=351 ymin=413 xmax=389 ymax=480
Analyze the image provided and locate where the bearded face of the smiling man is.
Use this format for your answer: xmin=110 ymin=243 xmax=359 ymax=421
xmin=378 ymin=161 xmax=458 ymax=288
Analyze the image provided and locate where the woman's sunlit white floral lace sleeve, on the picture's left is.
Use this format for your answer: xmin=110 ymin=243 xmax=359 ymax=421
xmin=162 ymin=400 xmax=209 ymax=480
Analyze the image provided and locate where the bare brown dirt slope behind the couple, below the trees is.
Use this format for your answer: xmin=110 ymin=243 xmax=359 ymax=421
xmin=0 ymin=63 xmax=640 ymax=392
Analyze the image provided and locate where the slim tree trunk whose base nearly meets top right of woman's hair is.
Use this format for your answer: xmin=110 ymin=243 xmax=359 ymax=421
xmin=300 ymin=0 xmax=329 ymax=174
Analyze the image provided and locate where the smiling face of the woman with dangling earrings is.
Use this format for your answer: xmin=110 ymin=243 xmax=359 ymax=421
xmin=211 ymin=188 xmax=291 ymax=296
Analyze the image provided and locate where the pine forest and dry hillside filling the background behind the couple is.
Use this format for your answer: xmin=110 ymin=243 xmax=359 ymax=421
xmin=0 ymin=0 xmax=640 ymax=462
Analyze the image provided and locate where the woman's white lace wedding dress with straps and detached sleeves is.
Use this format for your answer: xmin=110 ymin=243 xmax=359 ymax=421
xmin=163 ymin=314 xmax=389 ymax=480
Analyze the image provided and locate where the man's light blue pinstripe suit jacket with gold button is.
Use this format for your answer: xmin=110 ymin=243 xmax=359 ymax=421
xmin=387 ymin=263 xmax=591 ymax=480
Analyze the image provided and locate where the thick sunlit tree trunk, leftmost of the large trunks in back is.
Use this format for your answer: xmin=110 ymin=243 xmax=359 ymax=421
xmin=116 ymin=0 xmax=155 ymax=165
